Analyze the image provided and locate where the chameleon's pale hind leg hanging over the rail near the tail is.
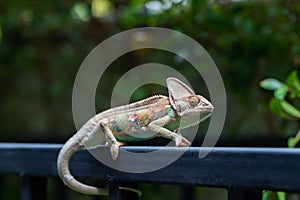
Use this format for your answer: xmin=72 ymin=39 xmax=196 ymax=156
xmin=100 ymin=123 xmax=124 ymax=160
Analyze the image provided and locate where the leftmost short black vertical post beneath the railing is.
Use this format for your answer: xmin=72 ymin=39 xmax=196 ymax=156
xmin=21 ymin=175 xmax=47 ymax=200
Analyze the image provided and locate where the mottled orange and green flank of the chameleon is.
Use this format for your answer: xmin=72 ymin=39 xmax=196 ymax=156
xmin=107 ymin=96 xmax=179 ymax=142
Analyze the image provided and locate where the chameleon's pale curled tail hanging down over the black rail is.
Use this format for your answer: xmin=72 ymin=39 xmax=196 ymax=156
xmin=57 ymin=118 xmax=108 ymax=195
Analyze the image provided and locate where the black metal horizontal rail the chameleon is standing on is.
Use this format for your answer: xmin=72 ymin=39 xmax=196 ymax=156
xmin=0 ymin=143 xmax=300 ymax=200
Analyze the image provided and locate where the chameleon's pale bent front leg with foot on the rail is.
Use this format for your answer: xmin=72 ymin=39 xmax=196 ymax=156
xmin=148 ymin=115 xmax=191 ymax=146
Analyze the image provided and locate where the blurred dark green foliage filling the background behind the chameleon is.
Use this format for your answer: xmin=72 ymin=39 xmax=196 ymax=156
xmin=0 ymin=0 xmax=300 ymax=199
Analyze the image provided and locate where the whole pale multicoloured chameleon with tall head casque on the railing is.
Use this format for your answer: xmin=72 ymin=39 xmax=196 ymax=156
xmin=57 ymin=77 xmax=214 ymax=195
